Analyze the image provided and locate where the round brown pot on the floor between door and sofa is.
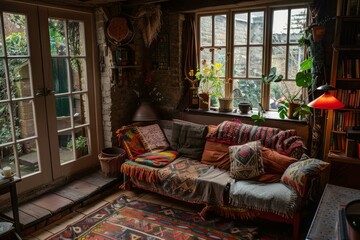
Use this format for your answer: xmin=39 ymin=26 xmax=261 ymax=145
xmin=99 ymin=147 xmax=125 ymax=177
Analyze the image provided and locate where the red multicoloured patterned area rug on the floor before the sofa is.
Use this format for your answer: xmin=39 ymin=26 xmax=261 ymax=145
xmin=47 ymin=195 xmax=257 ymax=240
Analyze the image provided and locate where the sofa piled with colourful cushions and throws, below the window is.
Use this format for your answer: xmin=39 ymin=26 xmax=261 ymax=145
xmin=117 ymin=119 xmax=329 ymax=239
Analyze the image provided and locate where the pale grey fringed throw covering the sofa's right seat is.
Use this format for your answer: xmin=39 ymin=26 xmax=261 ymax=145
xmin=229 ymin=180 xmax=300 ymax=218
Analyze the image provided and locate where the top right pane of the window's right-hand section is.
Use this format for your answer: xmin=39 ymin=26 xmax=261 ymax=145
xmin=290 ymin=8 xmax=307 ymax=43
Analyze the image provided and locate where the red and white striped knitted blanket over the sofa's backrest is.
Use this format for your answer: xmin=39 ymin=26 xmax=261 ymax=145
xmin=207 ymin=121 xmax=306 ymax=156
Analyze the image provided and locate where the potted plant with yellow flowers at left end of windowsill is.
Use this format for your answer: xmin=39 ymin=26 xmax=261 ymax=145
xmin=195 ymin=60 xmax=223 ymax=110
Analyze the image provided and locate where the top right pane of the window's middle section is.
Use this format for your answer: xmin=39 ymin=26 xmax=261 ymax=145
xmin=250 ymin=12 xmax=264 ymax=44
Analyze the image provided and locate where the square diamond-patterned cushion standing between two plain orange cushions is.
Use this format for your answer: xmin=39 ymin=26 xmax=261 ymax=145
xmin=229 ymin=141 xmax=264 ymax=180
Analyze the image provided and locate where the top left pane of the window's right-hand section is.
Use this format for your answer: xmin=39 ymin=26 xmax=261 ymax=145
xmin=272 ymin=10 xmax=288 ymax=43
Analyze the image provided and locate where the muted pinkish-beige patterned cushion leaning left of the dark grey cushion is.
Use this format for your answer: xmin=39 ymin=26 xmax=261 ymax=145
xmin=137 ymin=124 xmax=169 ymax=152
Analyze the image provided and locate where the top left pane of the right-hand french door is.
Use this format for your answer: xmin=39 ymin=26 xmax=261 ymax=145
xmin=49 ymin=18 xmax=67 ymax=56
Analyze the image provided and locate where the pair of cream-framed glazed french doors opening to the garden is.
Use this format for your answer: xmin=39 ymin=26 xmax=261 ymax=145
xmin=0 ymin=2 xmax=98 ymax=192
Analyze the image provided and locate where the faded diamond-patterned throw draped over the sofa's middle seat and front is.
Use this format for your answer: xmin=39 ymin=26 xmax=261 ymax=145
xmin=132 ymin=157 xmax=231 ymax=206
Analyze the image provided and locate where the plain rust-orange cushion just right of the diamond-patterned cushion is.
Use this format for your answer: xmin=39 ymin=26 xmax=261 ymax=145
xmin=261 ymin=147 xmax=298 ymax=173
